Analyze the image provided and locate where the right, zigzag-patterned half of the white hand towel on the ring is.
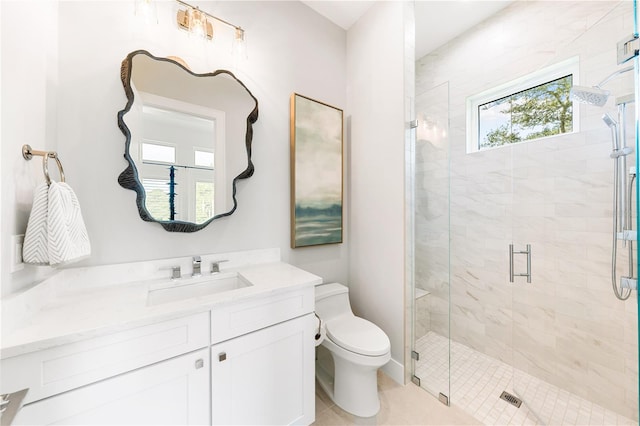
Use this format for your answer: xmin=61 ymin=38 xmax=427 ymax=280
xmin=47 ymin=182 xmax=91 ymax=266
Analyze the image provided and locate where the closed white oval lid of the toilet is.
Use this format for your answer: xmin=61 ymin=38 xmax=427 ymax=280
xmin=327 ymin=316 xmax=391 ymax=356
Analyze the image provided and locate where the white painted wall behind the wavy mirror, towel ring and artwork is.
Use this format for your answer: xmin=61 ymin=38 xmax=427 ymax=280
xmin=0 ymin=0 xmax=350 ymax=295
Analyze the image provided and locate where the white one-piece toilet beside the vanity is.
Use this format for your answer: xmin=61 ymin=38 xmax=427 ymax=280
xmin=315 ymin=283 xmax=391 ymax=417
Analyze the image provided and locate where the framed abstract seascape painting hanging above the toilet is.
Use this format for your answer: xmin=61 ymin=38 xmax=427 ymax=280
xmin=291 ymin=93 xmax=343 ymax=248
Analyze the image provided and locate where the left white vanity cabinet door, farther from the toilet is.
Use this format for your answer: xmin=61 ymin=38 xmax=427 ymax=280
xmin=15 ymin=349 xmax=209 ymax=425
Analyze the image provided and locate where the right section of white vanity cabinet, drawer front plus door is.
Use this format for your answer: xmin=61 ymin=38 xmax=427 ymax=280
xmin=211 ymin=287 xmax=315 ymax=425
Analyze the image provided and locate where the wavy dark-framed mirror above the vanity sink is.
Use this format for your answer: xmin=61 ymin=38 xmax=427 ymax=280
xmin=118 ymin=50 xmax=258 ymax=232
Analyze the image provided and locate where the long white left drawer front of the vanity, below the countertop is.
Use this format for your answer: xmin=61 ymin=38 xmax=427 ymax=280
xmin=0 ymin=312 xmax=209 ymax=403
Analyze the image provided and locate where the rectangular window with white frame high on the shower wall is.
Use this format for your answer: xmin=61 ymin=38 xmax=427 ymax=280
xmin=467 ymin=59 xmax=577 ymax=152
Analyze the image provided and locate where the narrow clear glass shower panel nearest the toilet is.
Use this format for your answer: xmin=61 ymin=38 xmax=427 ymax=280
xmin=412 ymin=83 xmax=451 ymax=404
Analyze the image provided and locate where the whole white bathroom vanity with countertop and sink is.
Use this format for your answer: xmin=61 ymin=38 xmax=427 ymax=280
xmin=0 ymin=249 xmax=321 ymax=425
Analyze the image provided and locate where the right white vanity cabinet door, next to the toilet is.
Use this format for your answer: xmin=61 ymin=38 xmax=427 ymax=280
xmin=211 ymin=314 xmax=315 ymax=425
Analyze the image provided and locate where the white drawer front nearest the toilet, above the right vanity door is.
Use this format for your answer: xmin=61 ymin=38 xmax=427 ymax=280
xmin=211 ymin=287 xmax=315 ymax=344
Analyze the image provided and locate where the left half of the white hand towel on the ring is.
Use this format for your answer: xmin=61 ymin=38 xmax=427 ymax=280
xmin=22 ymin=183 xmax=49 ymax=265
